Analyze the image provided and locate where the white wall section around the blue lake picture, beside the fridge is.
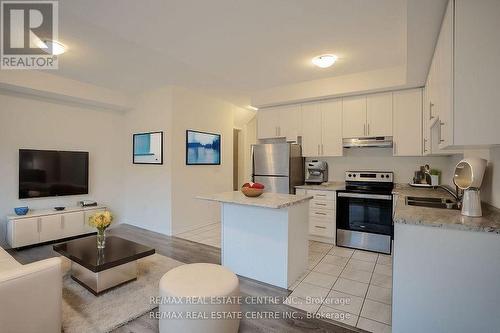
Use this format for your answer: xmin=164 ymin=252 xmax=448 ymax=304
xmin=172 ymin=87 xmax=235 ymax=234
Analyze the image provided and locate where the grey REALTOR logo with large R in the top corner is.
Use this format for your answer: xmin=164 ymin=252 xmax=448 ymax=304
xmin=0 ymin=1 xmax=58 ymax=69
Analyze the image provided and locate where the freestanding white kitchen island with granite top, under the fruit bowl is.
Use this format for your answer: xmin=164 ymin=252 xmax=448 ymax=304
xmin=197 ymin=191 xmax=312 ymax=288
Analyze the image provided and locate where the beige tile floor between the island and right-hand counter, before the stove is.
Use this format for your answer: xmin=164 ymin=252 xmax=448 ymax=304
xmin=285 ymin=241 xmax=392 ymax=333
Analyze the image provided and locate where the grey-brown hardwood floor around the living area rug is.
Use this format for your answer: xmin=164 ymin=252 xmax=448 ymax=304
xmin=9 ymin=224 xmax=365 ymax=333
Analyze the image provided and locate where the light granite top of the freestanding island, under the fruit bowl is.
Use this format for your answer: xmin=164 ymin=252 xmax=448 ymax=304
xmin=196 ymin=191 xmax=313 ymax=209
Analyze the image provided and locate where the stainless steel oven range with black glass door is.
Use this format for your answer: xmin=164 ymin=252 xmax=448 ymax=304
xmin=337 ymin=171 xmax=394 ymax=254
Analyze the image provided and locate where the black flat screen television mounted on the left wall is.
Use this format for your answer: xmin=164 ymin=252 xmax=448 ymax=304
xmin=19 ymin=149 xmax=89 ymax=199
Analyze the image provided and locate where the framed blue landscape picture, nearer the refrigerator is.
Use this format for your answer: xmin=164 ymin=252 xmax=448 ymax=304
xmin=186 ymin=130 xmax=221 ymax=165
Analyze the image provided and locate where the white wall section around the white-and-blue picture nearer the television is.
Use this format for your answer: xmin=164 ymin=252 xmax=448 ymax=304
xmin=122 ymin=87 xmax=173 ymax=235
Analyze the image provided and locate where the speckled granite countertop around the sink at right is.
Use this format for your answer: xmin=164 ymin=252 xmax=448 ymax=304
xmin=393 ymin=185 xmax=500 ymax=234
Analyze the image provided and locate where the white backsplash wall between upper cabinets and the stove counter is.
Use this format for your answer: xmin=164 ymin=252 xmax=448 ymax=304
xmin=307 ymin=148 xmax=454 ymax=184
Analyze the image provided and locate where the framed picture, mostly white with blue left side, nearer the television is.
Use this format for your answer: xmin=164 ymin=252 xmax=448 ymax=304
xmin=132 ymin=132 xmax=163 ymax=164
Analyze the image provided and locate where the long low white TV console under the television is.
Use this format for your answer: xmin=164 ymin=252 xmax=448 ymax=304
xmin=7 ymin=206 xmax=106 ymax=248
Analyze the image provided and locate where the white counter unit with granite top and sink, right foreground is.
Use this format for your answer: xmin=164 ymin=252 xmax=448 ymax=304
xmin=392 ymin=186 xmax=500 ymax=333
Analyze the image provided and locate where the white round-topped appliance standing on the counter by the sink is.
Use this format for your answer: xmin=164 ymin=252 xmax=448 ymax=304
xmin=453 ymin=157 xmax=487 ymax=217
